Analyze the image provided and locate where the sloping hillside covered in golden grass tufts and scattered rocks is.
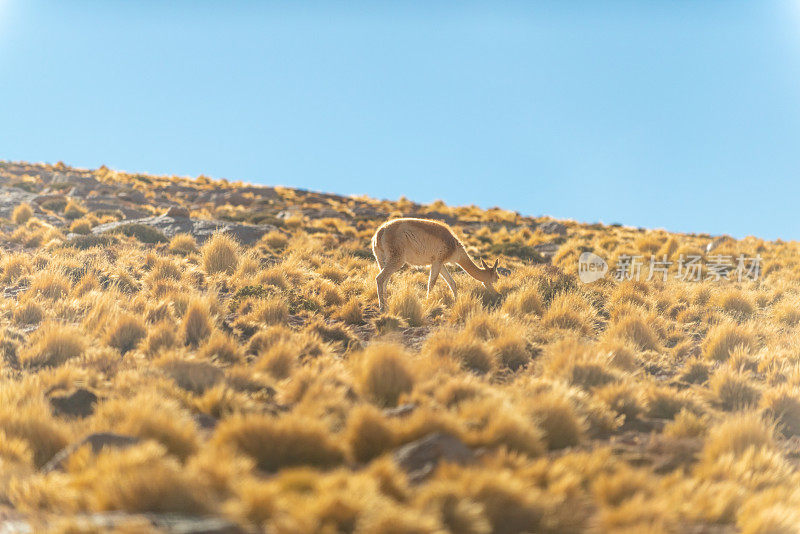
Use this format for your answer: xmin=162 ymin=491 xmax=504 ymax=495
xmin=0 ymin=162 xmax=800 ymax=533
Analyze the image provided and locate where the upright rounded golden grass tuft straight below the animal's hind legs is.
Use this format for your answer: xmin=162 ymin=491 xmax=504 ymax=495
xmin=359 ymin=344 xmax=414 ymax=406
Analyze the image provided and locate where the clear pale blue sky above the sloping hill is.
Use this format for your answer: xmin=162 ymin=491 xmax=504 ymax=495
xmin=0 ymin=0 xmax=800 ymax=239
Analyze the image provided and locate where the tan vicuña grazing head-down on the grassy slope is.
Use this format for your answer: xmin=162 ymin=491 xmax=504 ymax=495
xmin=372 ymin=218 xmax=499 ymax=311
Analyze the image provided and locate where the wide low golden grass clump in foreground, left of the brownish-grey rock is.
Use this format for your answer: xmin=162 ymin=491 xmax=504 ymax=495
xmin=214 ymin=415 xmax=345 ymax=471
